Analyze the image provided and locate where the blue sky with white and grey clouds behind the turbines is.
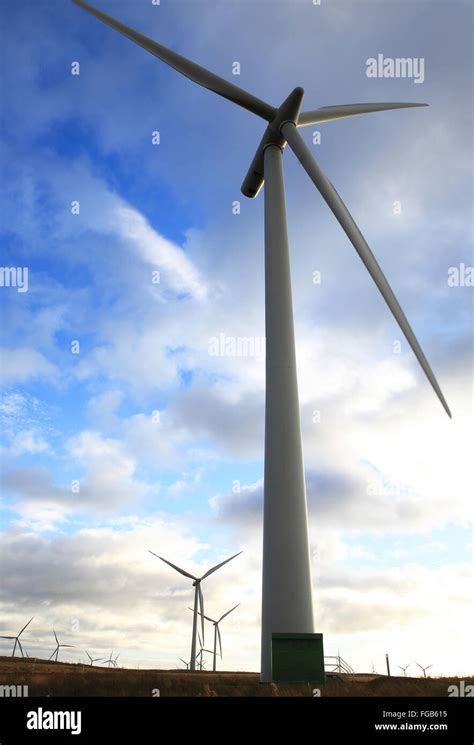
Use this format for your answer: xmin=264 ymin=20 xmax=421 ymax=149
xmin=0 ymin=0 xmax=474 ymax=675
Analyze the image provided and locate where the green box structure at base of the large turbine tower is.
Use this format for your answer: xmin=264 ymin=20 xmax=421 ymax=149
xmin=272 ymin=634 xmax=326 ymax=683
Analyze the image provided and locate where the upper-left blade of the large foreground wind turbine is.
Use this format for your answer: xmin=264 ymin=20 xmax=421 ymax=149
xmin=73 ymin=0 xmax=276 ymax=122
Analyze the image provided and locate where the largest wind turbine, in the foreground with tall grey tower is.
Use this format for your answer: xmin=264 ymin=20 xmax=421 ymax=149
xmin=73 ymin=0 xmax=451 ymax=682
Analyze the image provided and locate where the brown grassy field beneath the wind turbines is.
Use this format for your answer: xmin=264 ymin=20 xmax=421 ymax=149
xmin=0 ymin=657 xmax=474 ymax=697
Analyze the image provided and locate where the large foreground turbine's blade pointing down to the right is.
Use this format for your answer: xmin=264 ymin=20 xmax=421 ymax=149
xmin=282 ymin=124 xmax=451 ymax=418
